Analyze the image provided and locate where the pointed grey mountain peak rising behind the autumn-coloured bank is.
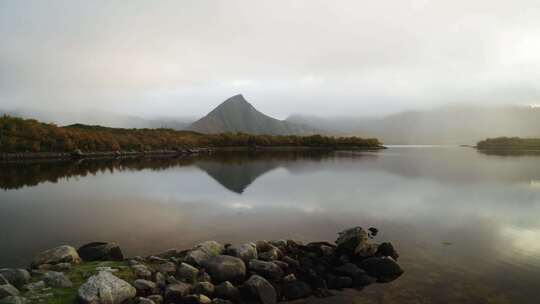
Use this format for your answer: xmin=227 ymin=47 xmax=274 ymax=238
xmin=187 ymin=94 xmax=320 ymax=135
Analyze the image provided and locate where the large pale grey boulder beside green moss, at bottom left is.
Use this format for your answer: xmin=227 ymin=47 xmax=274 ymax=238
xmin=78 ymin=271 xmax=137 ymax=304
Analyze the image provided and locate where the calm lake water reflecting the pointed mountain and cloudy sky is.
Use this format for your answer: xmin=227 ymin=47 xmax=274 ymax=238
xmin=0 ymin=147 xmax=540 ymax=303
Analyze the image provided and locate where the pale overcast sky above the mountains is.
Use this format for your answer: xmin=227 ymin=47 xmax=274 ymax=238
xmin=0 ymin=0 xmax=540 ymax=118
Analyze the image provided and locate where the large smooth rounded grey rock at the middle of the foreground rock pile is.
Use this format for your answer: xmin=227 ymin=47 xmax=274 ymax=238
xmin=203 ymin=255 xmax=246 ymax=283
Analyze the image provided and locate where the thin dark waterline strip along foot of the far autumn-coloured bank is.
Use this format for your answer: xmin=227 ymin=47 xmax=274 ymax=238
xmin=0 ymin=146 xmax=387 ymax=162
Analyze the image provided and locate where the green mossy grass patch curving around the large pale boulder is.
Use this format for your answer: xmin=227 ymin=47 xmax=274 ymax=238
xmin=25 ymin=261 xmax=136 ymax=304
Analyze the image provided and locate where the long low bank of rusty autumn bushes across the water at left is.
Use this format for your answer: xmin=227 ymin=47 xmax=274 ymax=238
xmin=0 ymin=115 xmax=381 ymax=153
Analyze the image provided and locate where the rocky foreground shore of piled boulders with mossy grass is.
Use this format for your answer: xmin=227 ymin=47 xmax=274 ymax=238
xmin=0 ymin=227 xmax=403 ymax=304
